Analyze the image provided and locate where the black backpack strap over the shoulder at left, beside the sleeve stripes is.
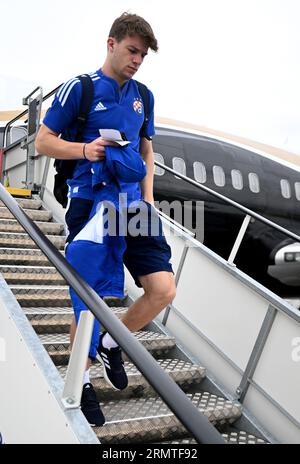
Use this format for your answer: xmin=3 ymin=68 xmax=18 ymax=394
xmin=75 ymin=74 xmax=94 ymax=142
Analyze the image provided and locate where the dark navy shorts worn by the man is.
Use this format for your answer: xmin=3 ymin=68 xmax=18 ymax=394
xmin=66 ymin=198 xmax=173 ymax=360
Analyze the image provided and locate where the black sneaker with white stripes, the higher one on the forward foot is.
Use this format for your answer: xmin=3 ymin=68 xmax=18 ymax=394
xmin=97 ymin=332 xmax=128 ymax=390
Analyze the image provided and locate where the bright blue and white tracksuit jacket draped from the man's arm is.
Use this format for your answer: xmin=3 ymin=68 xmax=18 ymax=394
xmin=66 ymin=145 xmax=146 ymax=359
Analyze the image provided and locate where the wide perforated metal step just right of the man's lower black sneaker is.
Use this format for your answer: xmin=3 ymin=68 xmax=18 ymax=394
xmin=94 ymin=392 xmax=242 ymax=444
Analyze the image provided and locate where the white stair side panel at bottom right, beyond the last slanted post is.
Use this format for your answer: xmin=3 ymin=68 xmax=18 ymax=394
xmin=245 ymin=312 xmax=300 ymax=443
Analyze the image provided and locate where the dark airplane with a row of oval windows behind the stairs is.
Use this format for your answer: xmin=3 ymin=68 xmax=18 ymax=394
xmin=153 ymin=119 xmax=300 ymax=298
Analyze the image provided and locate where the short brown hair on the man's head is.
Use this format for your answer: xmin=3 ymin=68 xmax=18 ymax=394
xmin=109 ymin=12 xmax=158 ymax=52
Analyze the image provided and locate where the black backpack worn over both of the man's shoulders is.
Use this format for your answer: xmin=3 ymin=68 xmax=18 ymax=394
xmin=53 ymin=74 xmax=150 ymax=208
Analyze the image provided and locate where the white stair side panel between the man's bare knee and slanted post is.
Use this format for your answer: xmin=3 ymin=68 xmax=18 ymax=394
xmin=166 ymin=237 xmax=269 ymax=376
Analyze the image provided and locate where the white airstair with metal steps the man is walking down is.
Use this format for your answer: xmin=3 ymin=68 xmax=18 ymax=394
xmin=0 ymin=85 xmax=300 ymax=445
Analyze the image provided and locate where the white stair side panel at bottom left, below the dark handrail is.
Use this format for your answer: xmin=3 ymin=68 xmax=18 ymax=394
xmin=0 ymin=278 xmax=97 ymax=444
